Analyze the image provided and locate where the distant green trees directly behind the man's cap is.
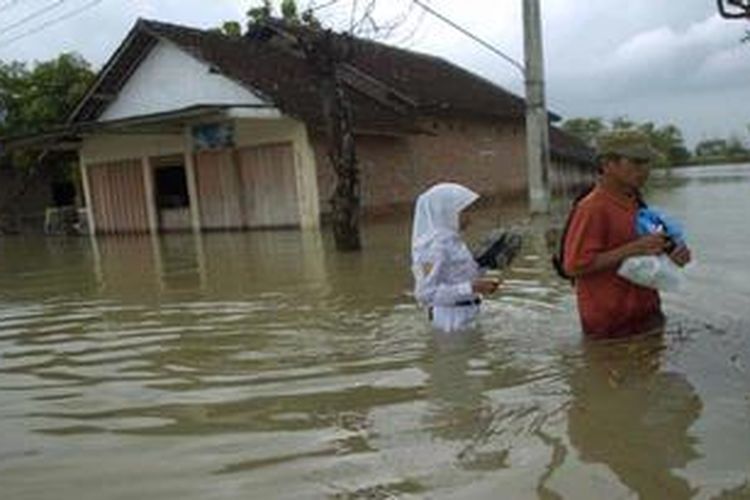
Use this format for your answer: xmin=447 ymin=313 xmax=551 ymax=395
xmin=562 ymin=116 xmax=690 ymax=167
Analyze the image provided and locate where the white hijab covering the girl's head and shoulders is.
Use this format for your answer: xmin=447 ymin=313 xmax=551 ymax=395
xmin=411 ymin=182 xmax=479 ymax=265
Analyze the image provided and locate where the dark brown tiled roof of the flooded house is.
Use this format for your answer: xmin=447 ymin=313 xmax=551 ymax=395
xmin=70 ymin=20 xmax=524 ymax=128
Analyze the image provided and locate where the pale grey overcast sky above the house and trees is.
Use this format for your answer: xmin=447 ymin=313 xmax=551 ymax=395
xmin=0 ymin=0 xmax=750 ymax=145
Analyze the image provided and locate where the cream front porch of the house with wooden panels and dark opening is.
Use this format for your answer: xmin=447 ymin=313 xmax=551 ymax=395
xmin=79 ymin=106 xmax=319 ymax=234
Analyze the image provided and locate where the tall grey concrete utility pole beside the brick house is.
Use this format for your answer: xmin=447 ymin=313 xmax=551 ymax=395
xmin=523 ymin=0 xmax=550 ymax=214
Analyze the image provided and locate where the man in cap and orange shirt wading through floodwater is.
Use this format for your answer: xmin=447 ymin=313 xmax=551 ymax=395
xmin=563 ymin=131 xmax=690 ymax=338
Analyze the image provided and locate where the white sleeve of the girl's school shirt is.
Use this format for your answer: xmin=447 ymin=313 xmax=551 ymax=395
xmin=414 ymin=245 xmax=475 ymax=306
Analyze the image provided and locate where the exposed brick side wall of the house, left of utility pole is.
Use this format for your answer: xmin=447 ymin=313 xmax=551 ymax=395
xmin=311 ymin=119 xmax=540 ymax=219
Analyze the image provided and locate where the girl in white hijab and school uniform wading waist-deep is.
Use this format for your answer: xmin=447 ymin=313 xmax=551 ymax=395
xmin=411 ymin=183 xmax=499 ymax=331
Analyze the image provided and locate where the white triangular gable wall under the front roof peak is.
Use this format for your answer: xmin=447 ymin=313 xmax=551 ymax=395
xmin=99 ymin=41 xmax=269 ymax=121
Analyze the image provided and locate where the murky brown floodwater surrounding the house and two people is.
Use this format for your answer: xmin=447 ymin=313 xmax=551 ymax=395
xmin=0 ymin=165 xmax=750 ymax=500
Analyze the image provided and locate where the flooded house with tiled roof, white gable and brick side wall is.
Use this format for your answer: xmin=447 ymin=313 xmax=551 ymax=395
xmin=4 ymin=20 xmax=593 ymax=233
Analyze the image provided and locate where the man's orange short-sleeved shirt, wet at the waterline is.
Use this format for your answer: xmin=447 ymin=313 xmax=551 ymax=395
xmin=564 ymin=186 xmax=662 ymax=337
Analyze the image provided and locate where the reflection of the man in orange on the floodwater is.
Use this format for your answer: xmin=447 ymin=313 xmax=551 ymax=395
xmin=568 ymin=335 xmax=702 ymax=499
